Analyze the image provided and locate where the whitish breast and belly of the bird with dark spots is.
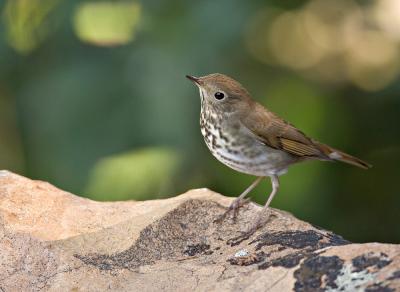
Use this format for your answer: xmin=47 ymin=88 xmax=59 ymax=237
xmin=200 ymin=109 xmax=291 ymax=176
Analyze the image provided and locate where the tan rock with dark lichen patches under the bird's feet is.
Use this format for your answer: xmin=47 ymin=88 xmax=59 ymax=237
xmin=0 ymin=171 xmax=400 ymax=292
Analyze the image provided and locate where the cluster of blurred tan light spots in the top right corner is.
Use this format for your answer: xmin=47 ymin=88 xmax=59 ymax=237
xmin=246 ymin=0 xmax=400 ymax=91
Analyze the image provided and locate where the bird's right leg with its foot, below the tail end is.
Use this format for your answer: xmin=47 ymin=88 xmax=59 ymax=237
xmin=227 ymin=175 xmax=279 ymax=246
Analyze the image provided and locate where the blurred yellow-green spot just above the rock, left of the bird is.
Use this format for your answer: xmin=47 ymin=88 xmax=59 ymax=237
xmin=85 ymin=147 xmax=181 ymax=200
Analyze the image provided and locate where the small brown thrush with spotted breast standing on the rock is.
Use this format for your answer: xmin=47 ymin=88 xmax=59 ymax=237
xmin=186 ymin=73 xmax=371 ymax=242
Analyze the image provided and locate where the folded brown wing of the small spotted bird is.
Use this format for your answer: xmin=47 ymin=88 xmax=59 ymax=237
xmin=242 ymin=104 xmax=328 ymax=159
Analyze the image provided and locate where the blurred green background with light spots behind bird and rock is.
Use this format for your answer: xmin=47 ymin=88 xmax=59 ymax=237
xmin=0 ymin=0 xmax=400 ymax=243
